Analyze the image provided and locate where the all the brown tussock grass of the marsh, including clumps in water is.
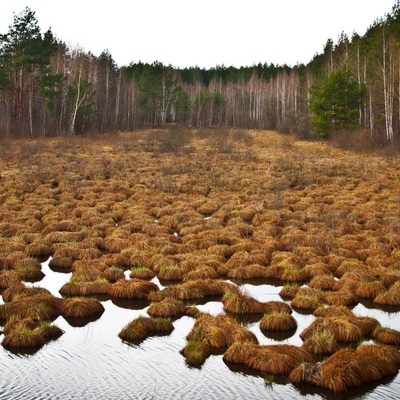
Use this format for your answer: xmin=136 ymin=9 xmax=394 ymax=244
xmin=0 ymin=130 xmax=400 ymax=398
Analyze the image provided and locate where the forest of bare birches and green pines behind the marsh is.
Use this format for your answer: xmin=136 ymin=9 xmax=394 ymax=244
xmin=0 ymin=1 xmax=400 ymax=145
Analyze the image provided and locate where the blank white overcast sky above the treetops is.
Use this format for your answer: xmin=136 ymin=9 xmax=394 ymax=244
xmin=0 ymin=0 xmax=395 ymax=68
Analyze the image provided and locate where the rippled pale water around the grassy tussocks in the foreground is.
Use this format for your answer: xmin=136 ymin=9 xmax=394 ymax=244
xmin=0 ymin=261 xmax=400 ymax=400
